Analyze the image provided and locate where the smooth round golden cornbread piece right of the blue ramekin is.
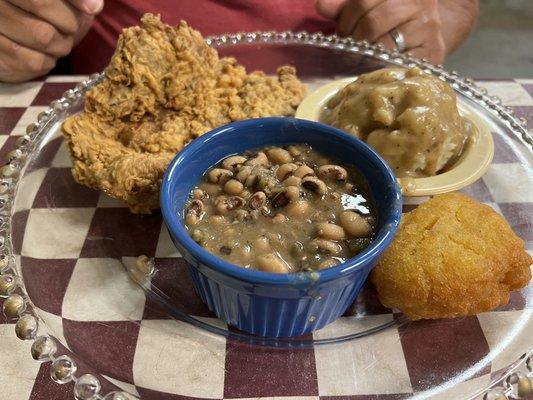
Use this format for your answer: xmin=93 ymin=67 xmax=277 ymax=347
xmin=371 ymin=193 xmax=532 ymax=320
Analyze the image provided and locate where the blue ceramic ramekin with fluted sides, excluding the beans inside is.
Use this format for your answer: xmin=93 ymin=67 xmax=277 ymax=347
xmin=161 ymin=118 xmax=402 ymax=337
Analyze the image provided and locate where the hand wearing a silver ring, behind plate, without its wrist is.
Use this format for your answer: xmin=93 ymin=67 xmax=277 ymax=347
xmin=315 ymin=0 xmax=446 ymax=64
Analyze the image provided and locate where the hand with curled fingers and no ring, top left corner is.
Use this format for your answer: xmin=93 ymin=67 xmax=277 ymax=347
xmin=0 ymin=0 xmax=103 ymax=82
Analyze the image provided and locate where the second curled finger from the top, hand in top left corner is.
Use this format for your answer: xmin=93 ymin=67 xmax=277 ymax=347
xmin=0 ymin=2 xmax=73 ymax=57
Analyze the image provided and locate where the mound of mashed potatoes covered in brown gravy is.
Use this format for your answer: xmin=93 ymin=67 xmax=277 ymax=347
xmin=321 ymin=68 xmax=473 ymax=178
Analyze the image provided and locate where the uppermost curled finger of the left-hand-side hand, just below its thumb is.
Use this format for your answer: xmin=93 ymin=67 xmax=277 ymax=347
xmin=2 ymin=0 xmax=82 ymax=35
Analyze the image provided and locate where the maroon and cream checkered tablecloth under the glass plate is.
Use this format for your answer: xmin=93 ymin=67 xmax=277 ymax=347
xmin=0 ymin=77 xmax=533 ymax=400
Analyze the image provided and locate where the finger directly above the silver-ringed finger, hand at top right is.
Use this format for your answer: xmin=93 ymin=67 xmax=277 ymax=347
xmin=352 ymin=0 xmax=419 ymax=43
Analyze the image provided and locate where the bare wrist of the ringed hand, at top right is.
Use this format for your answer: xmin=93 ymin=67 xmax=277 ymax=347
xmin=439 ymin=0 xmax=478 ymax=55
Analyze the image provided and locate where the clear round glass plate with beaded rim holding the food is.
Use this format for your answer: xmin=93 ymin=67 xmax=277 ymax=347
xmin=4 ymin=32 xmax=533 ymax=398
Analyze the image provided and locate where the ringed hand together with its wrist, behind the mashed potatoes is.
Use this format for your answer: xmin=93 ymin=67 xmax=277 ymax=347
xmin=315 ymin=0 xmax=478 ymax=64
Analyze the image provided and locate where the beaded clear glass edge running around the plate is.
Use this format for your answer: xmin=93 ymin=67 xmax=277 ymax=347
xmin=0 ymin=31 xmax=533 ymax=400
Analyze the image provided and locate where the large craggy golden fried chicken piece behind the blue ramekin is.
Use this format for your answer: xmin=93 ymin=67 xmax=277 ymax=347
xmin=63 ymin=14 xmax=306 ymax=213
